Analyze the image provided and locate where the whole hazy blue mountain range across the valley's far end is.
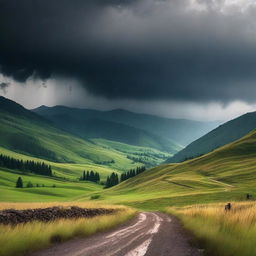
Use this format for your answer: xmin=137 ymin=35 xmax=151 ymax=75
xmin=33 ymin=106 xmax=219 ymax=147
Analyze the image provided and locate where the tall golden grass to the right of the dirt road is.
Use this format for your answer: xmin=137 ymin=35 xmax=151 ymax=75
xmin=167 ymin=202 xmax=256 ymax=256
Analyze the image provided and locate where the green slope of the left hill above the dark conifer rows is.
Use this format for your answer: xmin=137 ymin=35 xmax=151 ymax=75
xmin=0 ymin=103 xmax=170 ymax=177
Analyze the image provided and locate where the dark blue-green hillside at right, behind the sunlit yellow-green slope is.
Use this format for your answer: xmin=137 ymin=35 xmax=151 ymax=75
xmin=167 ymin=112 xmax=256 ymax=163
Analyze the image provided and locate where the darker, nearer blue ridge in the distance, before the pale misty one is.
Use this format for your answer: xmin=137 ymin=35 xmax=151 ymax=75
xmin=34 ymin=106 xmax=182 ymax=154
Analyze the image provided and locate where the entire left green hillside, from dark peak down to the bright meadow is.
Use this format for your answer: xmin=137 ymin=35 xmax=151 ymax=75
xmin=0 ymin=97 xmax=174 ymax=201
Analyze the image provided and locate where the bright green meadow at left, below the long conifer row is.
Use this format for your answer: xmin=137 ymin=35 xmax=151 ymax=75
xmin=0 ymin=168 xmax=102 ymax=202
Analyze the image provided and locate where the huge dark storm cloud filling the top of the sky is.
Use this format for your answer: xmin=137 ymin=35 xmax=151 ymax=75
xmin=0 ymin=0 xmax=256 ymax=101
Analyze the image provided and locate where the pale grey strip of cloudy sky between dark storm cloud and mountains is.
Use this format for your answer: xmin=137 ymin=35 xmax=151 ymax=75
xmin=0 ymin=75 xmax=256 ymax=121
